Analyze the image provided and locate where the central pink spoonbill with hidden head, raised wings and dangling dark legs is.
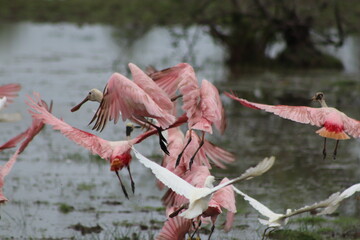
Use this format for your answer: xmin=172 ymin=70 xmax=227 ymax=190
xmin=150 ymin=63 xmax=226 ymax=168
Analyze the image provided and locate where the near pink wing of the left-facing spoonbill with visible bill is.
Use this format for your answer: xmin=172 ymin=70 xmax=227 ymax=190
xmin=90 ymin=73 xmax=175 ymax=130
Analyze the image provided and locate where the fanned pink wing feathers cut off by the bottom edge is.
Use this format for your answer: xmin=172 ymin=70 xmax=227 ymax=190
xmin=156 ymin=216 xmax=191 ymax=240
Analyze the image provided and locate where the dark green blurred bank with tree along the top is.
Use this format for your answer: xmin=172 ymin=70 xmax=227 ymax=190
xmin=0 ymin=0 xmax=360 ymax=69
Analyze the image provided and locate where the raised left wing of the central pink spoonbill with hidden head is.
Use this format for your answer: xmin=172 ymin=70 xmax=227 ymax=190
xmin=149 ymin=63 xmax=191 ymax=98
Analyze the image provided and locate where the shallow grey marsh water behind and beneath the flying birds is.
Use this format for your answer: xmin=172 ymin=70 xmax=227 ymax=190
xmin=0 ymin=23 xmax=360 ymax=239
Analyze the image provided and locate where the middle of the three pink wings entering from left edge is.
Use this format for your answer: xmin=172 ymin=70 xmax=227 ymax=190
xmin=0 ymin=96 xmax=52 ymax=154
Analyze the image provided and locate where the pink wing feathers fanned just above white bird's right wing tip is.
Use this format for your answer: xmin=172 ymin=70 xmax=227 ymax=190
xmin=202 ymin=139 xmax=235 ymax=168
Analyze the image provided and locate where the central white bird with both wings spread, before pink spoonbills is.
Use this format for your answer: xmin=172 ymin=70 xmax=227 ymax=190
xmin=132 ymin=147 xmax=275 ymax=219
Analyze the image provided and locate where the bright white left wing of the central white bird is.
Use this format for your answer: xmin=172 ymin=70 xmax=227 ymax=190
xmin=132 ymin=147 xmax=196 ymax=199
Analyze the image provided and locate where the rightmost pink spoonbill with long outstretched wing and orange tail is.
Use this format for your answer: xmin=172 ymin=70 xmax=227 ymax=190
xmin=225 ymin=92 xmax=360 ymax=159
